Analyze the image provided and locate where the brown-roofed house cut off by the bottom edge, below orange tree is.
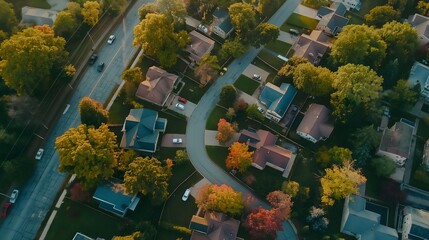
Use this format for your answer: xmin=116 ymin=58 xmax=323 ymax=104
xmin=191 ymin=211 xmax=240 ymax=240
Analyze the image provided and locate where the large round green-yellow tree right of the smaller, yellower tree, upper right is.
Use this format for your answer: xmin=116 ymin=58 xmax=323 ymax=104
xmin=331 ymin=64 xmax=383 ymax=123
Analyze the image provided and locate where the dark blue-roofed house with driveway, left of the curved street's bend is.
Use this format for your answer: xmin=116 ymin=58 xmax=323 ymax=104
xmin=120 ymin=108 xmax=167 ymax=153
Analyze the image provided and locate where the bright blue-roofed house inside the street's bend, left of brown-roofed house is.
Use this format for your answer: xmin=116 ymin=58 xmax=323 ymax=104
xmin=259 ymin=83 xmax=296 ymax=122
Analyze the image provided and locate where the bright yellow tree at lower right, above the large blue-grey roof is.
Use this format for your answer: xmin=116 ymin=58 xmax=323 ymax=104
xmin=320 ymin=161 xmax=366 ymax=206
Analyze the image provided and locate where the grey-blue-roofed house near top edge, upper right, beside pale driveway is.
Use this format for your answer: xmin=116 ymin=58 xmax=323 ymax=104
xmin=316 ymin=3 xmax=349 ymax=36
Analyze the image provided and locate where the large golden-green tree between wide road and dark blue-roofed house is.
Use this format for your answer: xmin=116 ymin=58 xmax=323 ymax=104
xmin=55 ymin=124 xmax=117 ymax=187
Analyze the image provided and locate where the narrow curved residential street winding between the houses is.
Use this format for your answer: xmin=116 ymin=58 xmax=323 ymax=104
xmin=186 ymin=0 xmax=300 ymax=240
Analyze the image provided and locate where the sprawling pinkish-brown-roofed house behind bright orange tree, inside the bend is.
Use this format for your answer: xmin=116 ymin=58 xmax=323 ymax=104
xmin=237 ymin=130 xmax=296 ymax=178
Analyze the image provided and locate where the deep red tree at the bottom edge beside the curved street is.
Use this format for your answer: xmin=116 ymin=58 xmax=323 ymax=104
xmin=245 ymin=207 xmax=283 ymax=239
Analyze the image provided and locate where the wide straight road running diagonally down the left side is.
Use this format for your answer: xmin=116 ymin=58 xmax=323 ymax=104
xmin=0 ymin=0 xmax=151 ymax=240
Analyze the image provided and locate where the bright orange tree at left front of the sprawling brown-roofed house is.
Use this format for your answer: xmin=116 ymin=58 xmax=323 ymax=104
xmin=225 ymin=142 xmax=253 ymax=173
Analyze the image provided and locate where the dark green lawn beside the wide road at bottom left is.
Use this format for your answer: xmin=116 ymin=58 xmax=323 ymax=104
xmin=45 ymin=199 xmax=123 ymax=240
